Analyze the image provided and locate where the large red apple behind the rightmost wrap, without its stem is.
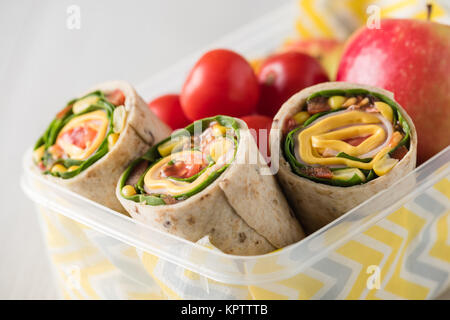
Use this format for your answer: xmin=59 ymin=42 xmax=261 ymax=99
xmin=337 ymin=19 xmax=450 ymax=164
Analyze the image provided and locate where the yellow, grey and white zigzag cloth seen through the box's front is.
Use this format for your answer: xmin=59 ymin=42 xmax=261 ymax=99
xmin=37 ymin=172 xmax=450 ymax=299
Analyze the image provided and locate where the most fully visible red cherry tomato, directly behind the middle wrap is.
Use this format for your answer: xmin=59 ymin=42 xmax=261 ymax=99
xmin=181 ymin=49 xmax=259 ymax=120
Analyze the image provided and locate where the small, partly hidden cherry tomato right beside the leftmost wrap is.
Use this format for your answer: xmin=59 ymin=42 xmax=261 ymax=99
xmin=148 ymin=94 xmax=191 ymax=130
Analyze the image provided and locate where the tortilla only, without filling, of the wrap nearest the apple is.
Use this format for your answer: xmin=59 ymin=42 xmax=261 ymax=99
xmin=270 ymin=82 xmax=417 ymax=233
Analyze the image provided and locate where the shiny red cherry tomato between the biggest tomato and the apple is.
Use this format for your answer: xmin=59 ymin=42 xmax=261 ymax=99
xmin=257 ymin=52 xmax=328 ymax=117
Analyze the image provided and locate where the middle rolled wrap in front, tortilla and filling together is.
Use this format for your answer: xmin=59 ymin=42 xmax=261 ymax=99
xmin=116 ymin=116 xmax=304 ymax=255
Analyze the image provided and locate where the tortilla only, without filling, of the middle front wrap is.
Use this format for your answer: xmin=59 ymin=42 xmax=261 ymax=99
xmin=116 ymin=120 xmax=304 ymax=255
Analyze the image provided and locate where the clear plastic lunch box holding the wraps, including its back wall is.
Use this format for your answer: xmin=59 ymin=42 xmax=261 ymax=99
xmin=21 ymin=5 xmax=450 ymax=299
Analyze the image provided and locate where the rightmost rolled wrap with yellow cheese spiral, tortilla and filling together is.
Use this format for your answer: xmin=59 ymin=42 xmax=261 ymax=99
xmin=270 ymin=82 xmax=417 ymax=232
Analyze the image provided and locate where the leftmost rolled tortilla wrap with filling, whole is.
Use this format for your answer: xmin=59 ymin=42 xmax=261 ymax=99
xmin=33 ymin=81 xmax=171 ymax=213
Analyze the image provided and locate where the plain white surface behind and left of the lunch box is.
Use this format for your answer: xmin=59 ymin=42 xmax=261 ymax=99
xmin=0 ymin=0 xmax=450 ymax=299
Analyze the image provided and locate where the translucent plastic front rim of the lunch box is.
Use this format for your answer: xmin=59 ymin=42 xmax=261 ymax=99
xmin=21 ymin=146 xmax=450 ymax=285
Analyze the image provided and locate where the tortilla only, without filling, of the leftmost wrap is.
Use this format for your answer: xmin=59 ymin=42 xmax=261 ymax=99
xmin=35 ymin=81 xmax=171 ymax=214
